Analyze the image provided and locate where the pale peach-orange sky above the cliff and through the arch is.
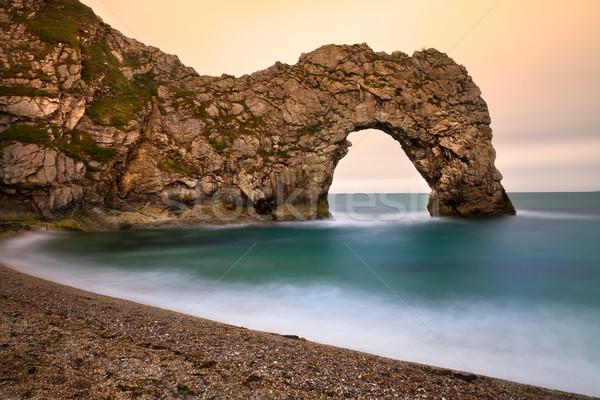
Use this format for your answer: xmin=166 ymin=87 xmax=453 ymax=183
xmin=83 ymin=0 xmax=600 ymax=192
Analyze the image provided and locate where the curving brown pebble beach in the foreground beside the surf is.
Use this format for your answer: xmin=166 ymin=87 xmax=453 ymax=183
xmin=0 ymin=228 xmax=591 ymax=399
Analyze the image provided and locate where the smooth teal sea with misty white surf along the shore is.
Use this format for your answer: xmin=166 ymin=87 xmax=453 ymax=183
xmin=0 ymin=192 xmax=600 ymax=396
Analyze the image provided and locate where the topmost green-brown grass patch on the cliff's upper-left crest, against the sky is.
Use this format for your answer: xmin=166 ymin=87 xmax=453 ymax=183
xmin=25 ymin=0 xmax=97 ymax=47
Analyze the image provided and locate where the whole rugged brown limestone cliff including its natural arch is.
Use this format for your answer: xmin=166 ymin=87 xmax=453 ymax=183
xmin=0 ymin=0 xmax=514 ymax=227
